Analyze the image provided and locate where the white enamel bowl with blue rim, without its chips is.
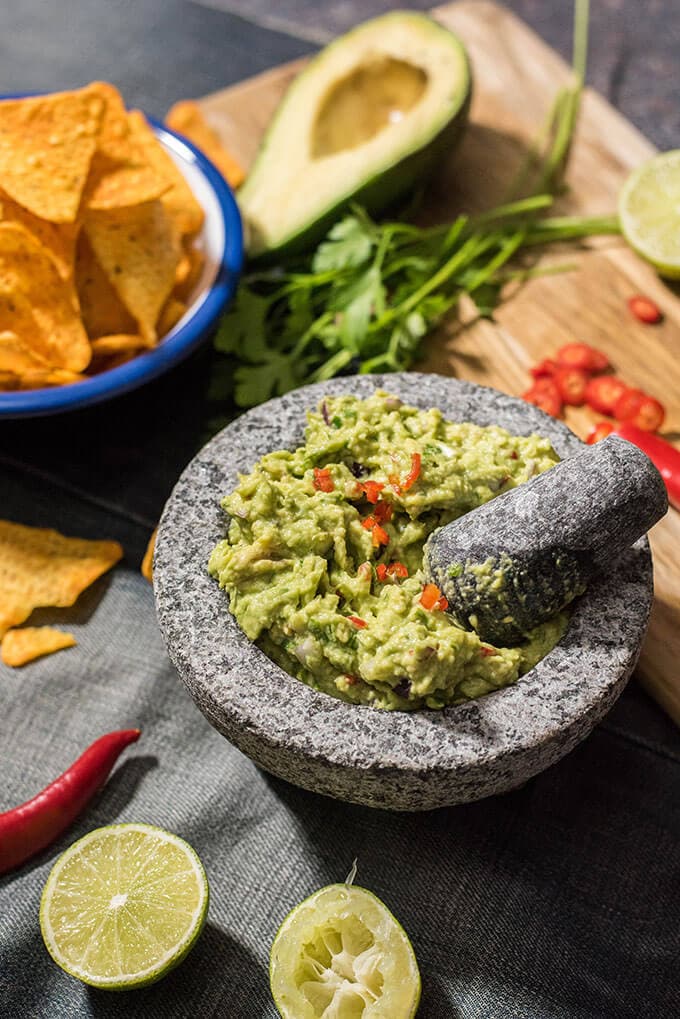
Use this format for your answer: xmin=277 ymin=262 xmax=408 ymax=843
xmin=0 ymin=117 xmax=244 ymax=418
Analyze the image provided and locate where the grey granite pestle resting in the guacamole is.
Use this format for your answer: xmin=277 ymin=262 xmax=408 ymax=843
xmin=424 ymin=436 xmax=668 ymax=647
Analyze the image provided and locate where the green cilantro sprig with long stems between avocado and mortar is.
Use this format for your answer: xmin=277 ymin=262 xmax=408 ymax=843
xmin=213 ymin=0 xmax=619 ymax=407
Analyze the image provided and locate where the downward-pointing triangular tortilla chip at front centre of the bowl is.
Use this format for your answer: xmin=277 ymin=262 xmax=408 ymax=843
xmin=85 ymin=200 xmax=180 ymax=343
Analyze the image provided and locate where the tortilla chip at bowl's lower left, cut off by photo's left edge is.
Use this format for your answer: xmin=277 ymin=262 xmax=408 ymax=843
xmin=0 ymin=222 xmax=90 ymax=372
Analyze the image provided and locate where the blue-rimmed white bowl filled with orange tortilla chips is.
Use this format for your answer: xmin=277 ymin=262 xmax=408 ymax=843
xmin=0 ymin=82 xmax=243 ymax=417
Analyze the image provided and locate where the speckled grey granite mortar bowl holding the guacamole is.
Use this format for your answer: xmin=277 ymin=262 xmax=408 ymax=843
xmin=154 ymin=373 xmax=652 ymax=810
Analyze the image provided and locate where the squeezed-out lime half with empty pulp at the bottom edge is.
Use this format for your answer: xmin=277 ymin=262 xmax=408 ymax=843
xmin=269 ymin=884 xmax=420 ymax=1019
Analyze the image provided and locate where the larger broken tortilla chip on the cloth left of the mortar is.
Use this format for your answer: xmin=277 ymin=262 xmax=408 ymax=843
xmin=0 ymin=520 xmax=122 ymax=637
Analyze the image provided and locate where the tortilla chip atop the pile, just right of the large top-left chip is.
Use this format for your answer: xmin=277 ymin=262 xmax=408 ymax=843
xmin=84 ymin=82 xmax=172 ymax=210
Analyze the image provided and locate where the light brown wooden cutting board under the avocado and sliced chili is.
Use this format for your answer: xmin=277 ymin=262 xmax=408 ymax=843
xmin=195 ymin=0 xmax=680 ymax=725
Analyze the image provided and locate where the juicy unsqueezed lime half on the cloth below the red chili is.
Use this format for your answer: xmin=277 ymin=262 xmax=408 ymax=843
xmin=40 ymin=824 xmax=208 ymax=990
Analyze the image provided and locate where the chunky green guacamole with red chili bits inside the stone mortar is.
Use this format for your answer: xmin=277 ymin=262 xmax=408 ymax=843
xmin=209 ymin=391 xmax=568 ymax=710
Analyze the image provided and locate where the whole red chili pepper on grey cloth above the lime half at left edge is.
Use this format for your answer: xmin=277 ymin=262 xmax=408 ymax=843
xmin=0 ymin=729 xmax=140 ymax=874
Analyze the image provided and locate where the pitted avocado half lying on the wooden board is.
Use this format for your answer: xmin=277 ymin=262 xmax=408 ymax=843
xmin=238 ymin=11 xmax=472 ymax=260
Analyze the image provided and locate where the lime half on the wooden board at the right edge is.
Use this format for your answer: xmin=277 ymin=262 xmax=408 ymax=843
xmin=619 ymin=149 xmax=680 ymax=279
